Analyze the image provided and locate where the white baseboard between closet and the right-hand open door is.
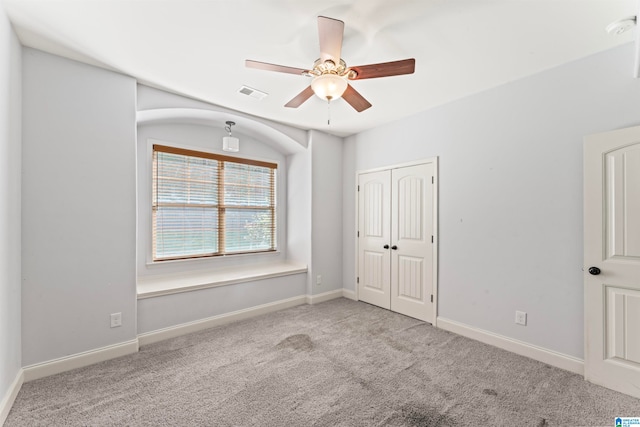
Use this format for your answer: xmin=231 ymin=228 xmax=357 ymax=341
xmin=437 ymin=317 xmax=584 ymax=375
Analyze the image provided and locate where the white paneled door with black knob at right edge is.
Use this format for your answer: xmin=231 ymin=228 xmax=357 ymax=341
xmin=584 ymin=127 xmax=640 ymax=397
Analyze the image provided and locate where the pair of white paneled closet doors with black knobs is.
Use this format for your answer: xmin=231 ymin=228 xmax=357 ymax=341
xmin=358 ymin=164 xmax=434 ymax=321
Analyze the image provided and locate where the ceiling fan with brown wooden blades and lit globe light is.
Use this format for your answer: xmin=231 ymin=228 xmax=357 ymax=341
xmin=245 ymin=16 xmax=416 ymax=112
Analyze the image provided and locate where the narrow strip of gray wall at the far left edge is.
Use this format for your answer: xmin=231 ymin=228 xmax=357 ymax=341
xmin=0 ymin=3 xmax=22 ymax=412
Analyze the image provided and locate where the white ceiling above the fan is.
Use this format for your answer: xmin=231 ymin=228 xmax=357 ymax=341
xmin=4 ymin=0 xmax=637 ymax=136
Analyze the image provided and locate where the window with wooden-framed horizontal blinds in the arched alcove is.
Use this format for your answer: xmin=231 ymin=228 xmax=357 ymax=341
xmin=152 ymin=145 xmax=277 ymax=261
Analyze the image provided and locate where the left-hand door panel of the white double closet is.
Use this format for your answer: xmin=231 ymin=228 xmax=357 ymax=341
xmin=357 ymin=170 xmax=391 ymax=309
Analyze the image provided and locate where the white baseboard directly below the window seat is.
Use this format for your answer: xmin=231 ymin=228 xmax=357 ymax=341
xmin=138 ymin=295 xmax=308 ymax=345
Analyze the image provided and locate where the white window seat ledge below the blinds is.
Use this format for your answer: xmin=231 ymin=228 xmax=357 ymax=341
xmin=137 ymin=262 xmax=307 ymax=299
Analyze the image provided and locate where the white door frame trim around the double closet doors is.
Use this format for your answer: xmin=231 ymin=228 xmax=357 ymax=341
xmin=354 ymin=156 xmax=440 ymax=326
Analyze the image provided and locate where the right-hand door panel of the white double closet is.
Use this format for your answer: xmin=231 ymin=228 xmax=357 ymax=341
xmin=391 ymin=163 xmax=434 ymax=322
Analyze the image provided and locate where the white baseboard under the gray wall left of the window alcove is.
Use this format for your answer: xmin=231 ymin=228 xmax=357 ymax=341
xmin=23 ymin=339 xmax=138 ymax=382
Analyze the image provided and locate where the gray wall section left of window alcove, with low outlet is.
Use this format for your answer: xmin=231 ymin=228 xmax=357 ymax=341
xmin=22 ymin=48 xmax=136 ymax=366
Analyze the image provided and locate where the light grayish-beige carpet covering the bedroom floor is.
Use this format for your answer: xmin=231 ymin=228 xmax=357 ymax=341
xmin=5 ymin=299 xmax=640 ymax=427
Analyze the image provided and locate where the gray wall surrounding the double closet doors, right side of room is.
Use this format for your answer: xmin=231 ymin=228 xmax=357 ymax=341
xmin=343 ymin=44 xmax=640 ymax=358
